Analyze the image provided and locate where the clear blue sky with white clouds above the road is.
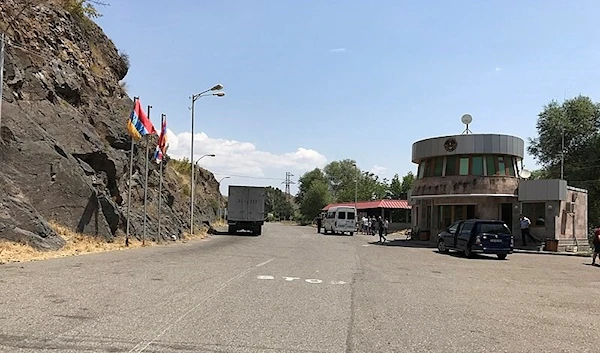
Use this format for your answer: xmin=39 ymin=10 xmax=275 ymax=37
xmin=96 ymin=0 xmax=600 ymax=194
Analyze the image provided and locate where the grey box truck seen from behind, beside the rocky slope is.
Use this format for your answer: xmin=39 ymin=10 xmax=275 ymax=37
xmin=227 ymin=185 xmax=266 ymax=235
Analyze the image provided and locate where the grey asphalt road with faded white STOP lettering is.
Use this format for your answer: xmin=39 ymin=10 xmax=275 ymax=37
xmin=0 ymin=224 xmax=600 ymax=353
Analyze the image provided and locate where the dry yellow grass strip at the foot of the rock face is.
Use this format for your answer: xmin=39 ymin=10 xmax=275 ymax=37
xmin=0 ymin=222 xmax=207 ymax=264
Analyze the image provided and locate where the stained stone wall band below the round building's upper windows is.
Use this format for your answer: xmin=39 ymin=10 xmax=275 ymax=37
xmin=411 ymin=175 xmax=519 ymax=197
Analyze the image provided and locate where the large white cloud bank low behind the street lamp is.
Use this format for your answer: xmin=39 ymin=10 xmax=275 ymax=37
xmin=167 ymin=129 xmax=327 ymax=180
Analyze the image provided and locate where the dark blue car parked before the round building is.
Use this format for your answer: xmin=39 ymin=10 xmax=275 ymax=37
xmin=438 ymin=219 xmax=515 ymax=260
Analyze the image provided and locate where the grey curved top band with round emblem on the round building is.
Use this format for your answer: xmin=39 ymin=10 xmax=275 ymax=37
xmin=412 ymin=134 xmax=525 ymax=164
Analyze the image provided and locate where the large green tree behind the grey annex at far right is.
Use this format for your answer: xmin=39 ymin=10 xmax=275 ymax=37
xmin=527 ymin=96 xmax=600 ymax=225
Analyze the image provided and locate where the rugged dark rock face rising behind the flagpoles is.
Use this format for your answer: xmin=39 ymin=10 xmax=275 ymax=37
xmin=0 ymin=0 xmax=220 ymax=249
